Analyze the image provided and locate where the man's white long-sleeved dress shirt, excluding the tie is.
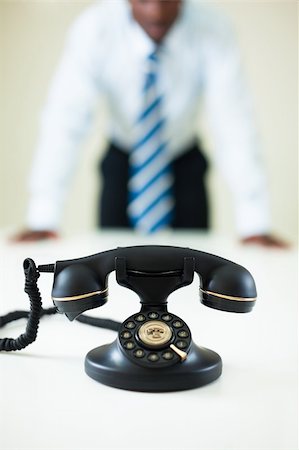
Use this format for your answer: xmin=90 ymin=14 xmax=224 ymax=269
xmin=27 ymin=0 xmax=269 ymax=237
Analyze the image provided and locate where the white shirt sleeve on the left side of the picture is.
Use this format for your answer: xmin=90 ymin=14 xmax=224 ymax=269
xmin=27 ymin=10 xmax=103 ymax=230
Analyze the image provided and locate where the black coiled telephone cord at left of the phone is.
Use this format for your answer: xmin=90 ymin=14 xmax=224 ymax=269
xmin=0 ymin=258 xmax=121 ymax=352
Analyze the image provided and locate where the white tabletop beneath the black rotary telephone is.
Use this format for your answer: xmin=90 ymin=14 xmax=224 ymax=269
xmin=0 ymin=232 xmax=298 ymax=450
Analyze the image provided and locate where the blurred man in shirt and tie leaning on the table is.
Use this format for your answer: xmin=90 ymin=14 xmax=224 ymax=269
xmin=17 ymin=0 xmax=288 ymax=246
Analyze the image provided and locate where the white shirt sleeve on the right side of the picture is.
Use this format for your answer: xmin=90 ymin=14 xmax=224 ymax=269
xmin=205 ymin=19 xmax=270 ymax=237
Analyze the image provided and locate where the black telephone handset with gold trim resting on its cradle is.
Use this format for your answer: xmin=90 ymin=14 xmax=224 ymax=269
xmin=52 ymin=246 xmax=257 ymax=320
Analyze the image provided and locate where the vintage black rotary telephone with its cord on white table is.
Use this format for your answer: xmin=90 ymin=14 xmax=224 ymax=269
xmin=0 ymin=246 xmax=257 ymax=392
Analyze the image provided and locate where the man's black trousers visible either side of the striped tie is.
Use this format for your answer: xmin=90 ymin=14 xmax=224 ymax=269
xmin=98 ymin=144 xmax=209 ymax=229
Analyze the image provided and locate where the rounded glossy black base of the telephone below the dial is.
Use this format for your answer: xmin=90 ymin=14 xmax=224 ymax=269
xmin=85 ymin=341 xmax=222 ymax=392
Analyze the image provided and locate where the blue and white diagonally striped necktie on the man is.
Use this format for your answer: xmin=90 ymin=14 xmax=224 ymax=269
xmin=128 ymin=53 xmax=174 ymax=233
